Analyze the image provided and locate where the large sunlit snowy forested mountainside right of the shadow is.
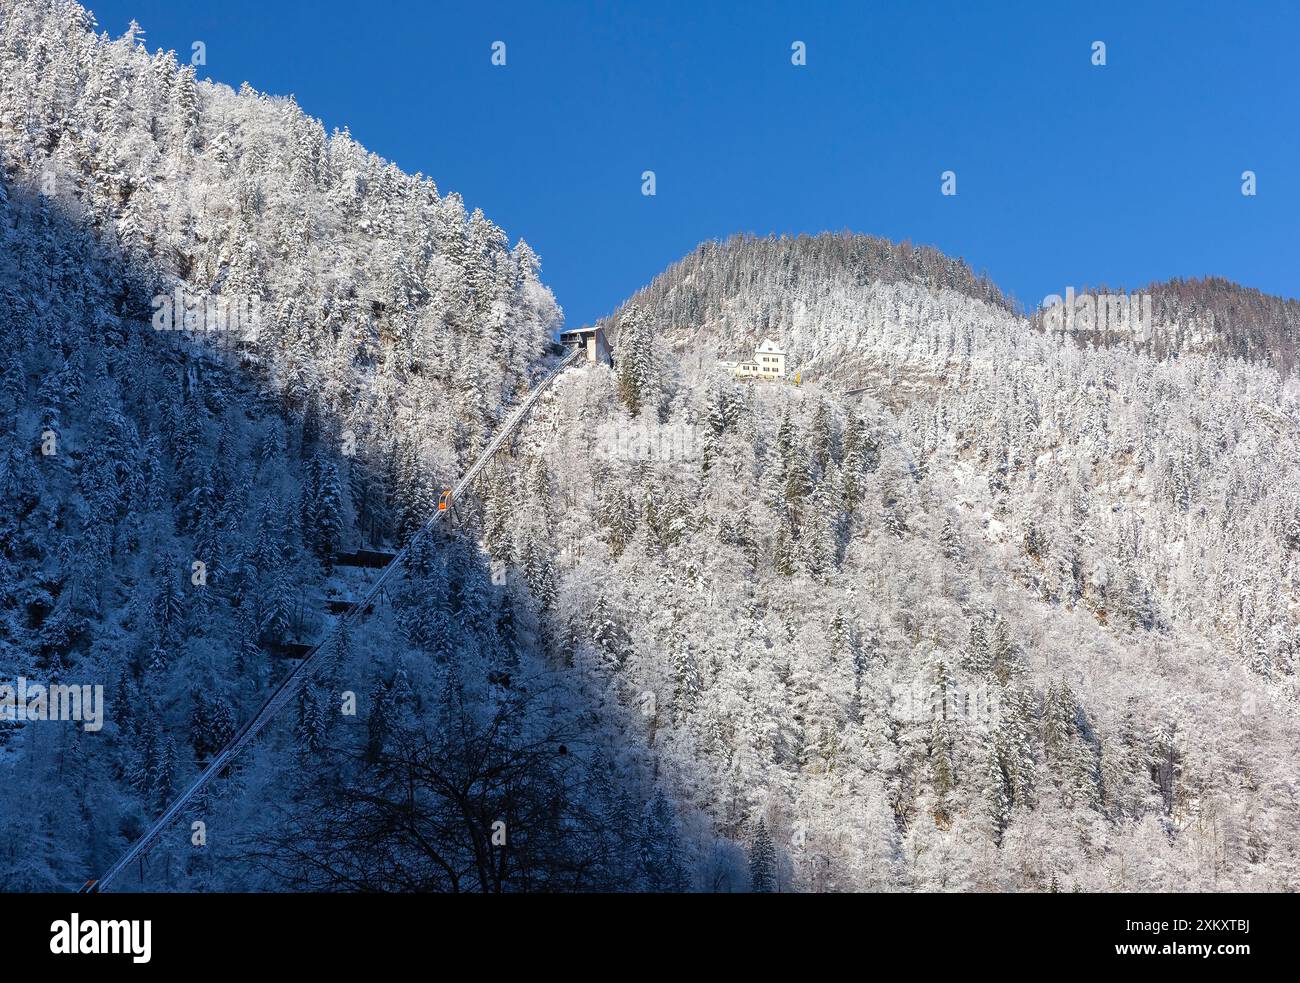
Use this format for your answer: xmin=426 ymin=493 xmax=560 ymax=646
xmin=486 ymin=237 xmax=1300 ymax=891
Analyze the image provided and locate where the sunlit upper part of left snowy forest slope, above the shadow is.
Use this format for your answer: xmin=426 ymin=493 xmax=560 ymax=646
xmin=0 ymin=1 xmax=559 ymax=481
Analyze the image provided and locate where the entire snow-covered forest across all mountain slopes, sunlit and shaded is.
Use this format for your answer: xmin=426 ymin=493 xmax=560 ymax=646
xmin=0 ymin=0 xmax=1300 ymax=892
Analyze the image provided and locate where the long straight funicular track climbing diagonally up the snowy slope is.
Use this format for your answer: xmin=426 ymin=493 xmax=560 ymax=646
xmin=78 ymin=347 xmax=584 ymax=893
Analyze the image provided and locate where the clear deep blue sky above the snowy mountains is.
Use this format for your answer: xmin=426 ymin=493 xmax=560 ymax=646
xmin=90 ymin=0 xmax=1300 ymax=325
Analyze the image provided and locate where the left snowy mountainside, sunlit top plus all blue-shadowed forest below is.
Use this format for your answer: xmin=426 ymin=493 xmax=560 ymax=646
xmin=0 ymin=0 xmax=684 ymax=891
